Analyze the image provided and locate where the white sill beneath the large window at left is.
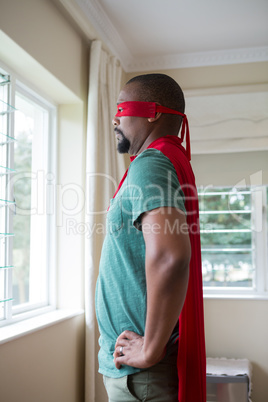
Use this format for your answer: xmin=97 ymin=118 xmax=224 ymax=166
xmin=0 ymin=309 xmax=84 ymax=345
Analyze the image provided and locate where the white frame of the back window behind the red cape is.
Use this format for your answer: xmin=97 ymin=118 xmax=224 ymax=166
xmin=198 ymin=185 xmax=268 ymax=300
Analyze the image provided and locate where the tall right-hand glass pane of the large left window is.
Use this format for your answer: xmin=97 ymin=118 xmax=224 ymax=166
xmin=13 ymin=93 xmax=48 ymax=306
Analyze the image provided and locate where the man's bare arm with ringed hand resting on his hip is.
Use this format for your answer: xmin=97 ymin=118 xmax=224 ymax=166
xmin=114 ymin=207 xmax=191 ymax=368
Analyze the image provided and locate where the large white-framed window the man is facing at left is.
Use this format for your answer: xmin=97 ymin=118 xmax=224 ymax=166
xmin=0 ymin=63 xmax=55 ymax=325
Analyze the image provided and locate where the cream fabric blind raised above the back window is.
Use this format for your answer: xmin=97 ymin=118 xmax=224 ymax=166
xmin=185 ymin=84 xmax=268 ymax=154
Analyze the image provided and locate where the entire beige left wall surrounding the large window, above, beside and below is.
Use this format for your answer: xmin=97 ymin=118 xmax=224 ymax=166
xmin=0 ymin=0 xmax=89 ymax=402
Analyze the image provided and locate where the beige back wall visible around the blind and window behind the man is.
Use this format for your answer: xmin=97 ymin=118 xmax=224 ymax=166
xmin=126 ymin=63 xmax=268 ymax=402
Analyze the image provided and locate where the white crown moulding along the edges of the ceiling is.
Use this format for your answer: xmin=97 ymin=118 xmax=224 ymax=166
xmin=74 ymin=0 xmax=268 ymax=72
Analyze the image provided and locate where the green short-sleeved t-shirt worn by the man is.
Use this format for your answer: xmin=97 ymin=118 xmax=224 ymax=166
xmin=96 ymin=148 xmax=186 ymax=378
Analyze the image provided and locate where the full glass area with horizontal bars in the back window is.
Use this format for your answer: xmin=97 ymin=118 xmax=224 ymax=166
xmin=199 ymin=188 xmax=255 ymax=288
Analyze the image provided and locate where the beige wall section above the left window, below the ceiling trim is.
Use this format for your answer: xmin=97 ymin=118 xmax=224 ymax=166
xmin=0 ymin=0 xmax=88 ymax=99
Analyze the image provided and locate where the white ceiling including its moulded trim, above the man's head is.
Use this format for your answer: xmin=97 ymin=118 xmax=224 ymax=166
xmin=62 ymin=0 xmax=268 ymax=72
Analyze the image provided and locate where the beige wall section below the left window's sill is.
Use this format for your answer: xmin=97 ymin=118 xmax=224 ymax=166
xmin=0 ymin=315 xmax=84 ymax=402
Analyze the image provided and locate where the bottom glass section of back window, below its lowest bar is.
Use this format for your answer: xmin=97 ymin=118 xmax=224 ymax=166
xmin=202 ymin=250 xmax=254 ymax=287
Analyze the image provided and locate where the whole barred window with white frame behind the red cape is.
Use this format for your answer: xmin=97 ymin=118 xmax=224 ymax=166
xmin=198 ymin=186 xmax=267 ymax=296
